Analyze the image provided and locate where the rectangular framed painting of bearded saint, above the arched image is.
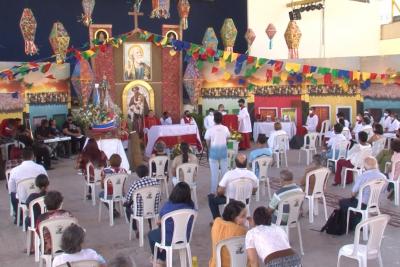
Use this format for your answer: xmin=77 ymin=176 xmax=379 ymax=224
xmin=123 ymin=42 xmax=152 ymax=81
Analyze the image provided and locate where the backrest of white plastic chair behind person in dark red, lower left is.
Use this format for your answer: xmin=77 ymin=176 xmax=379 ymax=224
xmin=39 ymin=217 xmax=78 ymax=256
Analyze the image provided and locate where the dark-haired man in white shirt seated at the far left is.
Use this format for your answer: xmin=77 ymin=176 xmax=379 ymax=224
xmin=8 ymin=147 xmax=47 ymax=223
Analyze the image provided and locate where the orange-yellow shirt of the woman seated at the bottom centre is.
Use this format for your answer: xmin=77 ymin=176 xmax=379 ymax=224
xmin=208 ymin=218 xmax=247 ymax=267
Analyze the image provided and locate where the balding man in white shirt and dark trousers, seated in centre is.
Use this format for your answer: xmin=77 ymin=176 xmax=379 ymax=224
xmin=208 ymin=153 xmax=257 ymax=219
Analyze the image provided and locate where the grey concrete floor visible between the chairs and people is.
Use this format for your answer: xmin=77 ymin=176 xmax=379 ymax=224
xmin=0 ymin=151 xmax=400 ymax=267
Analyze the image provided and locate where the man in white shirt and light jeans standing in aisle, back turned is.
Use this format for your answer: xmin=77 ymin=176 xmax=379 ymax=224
xmin=204 ymin=112 xmax=231 ymax=193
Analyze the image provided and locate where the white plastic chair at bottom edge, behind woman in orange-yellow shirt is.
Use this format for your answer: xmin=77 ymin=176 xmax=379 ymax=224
xmin=215 ymin=236 xmax=247 ymax=267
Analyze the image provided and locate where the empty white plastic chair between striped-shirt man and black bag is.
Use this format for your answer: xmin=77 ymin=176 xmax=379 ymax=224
xmin=305 ymin=168 xmax=331 ymax=223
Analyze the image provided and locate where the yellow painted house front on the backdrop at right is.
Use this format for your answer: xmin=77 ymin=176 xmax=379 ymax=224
xmin=309 ymin=95 xmax=360 ymax=125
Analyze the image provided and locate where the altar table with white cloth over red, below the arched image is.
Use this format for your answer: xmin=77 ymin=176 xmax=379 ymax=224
xmin=145 ymin=124 xmax=203 ymax=157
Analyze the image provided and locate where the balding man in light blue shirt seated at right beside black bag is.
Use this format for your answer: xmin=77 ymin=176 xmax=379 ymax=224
xmin=339 ymin=157 xmax=386 ymax=229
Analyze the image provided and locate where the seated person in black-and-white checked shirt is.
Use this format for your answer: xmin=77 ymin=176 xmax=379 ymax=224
xmin=124 ymin=165 xmax=161 ymax=238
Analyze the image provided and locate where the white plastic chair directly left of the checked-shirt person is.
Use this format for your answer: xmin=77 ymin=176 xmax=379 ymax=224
xmin=99 ymin=173 xmax=128 ymax=226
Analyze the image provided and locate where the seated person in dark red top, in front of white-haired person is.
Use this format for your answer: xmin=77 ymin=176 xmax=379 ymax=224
xmin=36 ymin=191 xmax=73 ymax=254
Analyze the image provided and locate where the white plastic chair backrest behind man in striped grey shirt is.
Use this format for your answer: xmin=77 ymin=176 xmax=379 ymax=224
xmin=276 ymin=192 xmax=305 ymax=227
